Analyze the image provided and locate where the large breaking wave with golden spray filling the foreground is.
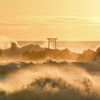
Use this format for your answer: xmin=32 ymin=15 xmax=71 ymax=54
xmin=0 ymin=60 xmax=100 ymax=100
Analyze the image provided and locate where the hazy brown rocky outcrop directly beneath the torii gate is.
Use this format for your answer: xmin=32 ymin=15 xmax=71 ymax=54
xmin=22 ymin=48 xmax=79 ymax=61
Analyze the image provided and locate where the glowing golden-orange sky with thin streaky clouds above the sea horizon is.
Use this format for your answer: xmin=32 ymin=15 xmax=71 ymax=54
xmin=0 ymin=0 xmax=100 ymax=41
